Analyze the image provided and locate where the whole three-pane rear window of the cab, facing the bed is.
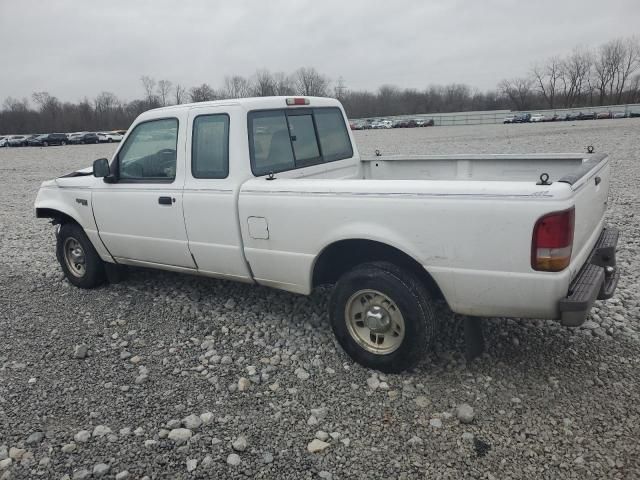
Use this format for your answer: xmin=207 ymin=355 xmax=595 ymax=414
xmin=248 ymin=107 xmax=353 ymax=176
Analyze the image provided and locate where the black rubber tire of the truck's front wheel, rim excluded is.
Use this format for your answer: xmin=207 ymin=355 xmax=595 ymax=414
xmin=56 ymin=223 xmax=106 ymax=289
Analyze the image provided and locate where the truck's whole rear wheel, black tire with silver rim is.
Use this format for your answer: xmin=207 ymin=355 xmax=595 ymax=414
xmin=330 ymin=262 xmax=436 ymax=373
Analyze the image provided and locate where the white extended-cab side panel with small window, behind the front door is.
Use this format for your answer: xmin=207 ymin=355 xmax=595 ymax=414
xmin=183 ymin=106 xmax=251 ymax=281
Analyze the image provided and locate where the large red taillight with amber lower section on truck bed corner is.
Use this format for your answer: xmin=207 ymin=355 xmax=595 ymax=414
xmin=531 ymin=207 xmax=575 ymax=272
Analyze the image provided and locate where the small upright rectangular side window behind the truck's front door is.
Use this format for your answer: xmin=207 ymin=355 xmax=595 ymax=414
xmin=191 ymin=114 xmax=229 ymax=178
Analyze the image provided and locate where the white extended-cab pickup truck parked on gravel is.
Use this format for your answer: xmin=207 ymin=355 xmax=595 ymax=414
xmin=35 ymin=97 xmax=618 ymax=371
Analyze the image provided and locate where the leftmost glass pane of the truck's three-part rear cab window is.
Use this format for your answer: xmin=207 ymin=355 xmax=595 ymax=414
xmin=249 ymin=110 xmax=295 ymax=175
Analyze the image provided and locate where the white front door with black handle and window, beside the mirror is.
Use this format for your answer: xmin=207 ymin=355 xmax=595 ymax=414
xmin=92 ymin=115 xmax=196 ymax=269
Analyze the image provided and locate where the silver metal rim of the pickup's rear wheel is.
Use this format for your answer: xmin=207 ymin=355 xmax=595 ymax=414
xmin=344 ymin=289 xmax=405 ymax=355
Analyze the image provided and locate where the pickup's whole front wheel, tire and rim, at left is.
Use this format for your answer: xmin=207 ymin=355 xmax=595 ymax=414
xmin=56 ymin=223 xmax=105 ymax=288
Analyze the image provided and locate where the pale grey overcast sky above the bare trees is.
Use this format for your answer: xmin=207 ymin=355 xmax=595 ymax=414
xmin=0 ymin=0 xmax=640 ymax=102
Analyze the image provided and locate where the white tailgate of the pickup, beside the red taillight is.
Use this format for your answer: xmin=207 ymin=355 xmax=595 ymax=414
xmin=560 ymin=154 xmax=611 ymax=276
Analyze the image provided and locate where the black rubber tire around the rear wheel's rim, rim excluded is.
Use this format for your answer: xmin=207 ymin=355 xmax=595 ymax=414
xmin=329 ymin=262 xmax=437 ymax=373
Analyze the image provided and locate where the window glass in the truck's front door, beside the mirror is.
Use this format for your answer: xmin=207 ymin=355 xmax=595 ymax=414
xmin=118 ymin=118 xmax=178 ymax=182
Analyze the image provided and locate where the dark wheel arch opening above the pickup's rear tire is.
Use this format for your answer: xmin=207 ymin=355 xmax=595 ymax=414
xmin=311 ymin=238 xmax=445 ymax=299
